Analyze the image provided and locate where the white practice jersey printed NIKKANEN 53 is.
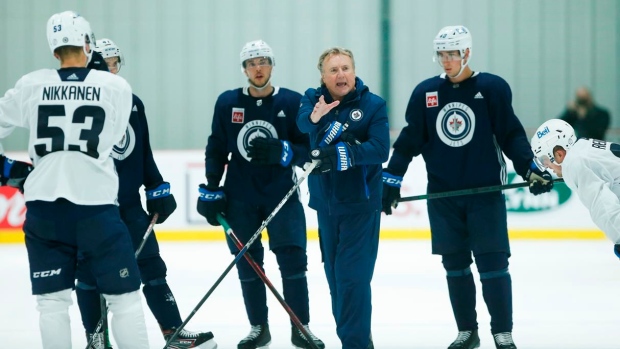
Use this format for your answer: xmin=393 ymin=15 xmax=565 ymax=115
xmin=0 ymin=68 xmax=132 ymax=205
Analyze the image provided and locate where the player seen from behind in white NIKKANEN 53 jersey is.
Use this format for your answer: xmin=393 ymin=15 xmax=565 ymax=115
xmin=0 ymin=11 xmax=148 ymax=349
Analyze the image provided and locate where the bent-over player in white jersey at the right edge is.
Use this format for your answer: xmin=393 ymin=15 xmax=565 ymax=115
xmin=531 ymin=119 xmax=620 ymax=258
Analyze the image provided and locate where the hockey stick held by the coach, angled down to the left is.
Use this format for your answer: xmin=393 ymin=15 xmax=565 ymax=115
xmin=164 ymin=161 xmax=320 ymax=349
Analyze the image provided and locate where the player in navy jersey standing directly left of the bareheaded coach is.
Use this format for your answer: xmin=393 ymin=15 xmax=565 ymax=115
xmin=197 ymin=40 xmax=325 ymax=349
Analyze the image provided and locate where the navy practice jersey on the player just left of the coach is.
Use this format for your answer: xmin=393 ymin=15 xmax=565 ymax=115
xmin=205 ymin=87 xmax=309 ymax=205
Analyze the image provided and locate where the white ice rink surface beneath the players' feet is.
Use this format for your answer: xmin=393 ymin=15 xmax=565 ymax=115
xmin=0 ymin=240 xmax=620 ymax=349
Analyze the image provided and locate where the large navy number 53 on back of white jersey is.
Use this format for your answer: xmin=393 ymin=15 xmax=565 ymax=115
xmin=34 ymin=105 xmax=105 ymax=158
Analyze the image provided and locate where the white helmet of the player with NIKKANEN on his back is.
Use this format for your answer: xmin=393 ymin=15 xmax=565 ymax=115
xmin=47 ymin=11 xmax=95 ymax=62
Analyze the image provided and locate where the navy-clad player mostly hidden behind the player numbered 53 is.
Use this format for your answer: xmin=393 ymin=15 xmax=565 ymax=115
xmin=76 ymin=39 xmax=217 ymax=349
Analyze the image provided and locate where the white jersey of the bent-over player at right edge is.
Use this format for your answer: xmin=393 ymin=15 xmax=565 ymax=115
xmin=562 ymin=138 xmax=620 ymax=244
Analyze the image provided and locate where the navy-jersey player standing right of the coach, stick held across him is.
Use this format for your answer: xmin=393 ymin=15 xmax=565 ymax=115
xmin=383 ymin=26 xmax=553 ymax=349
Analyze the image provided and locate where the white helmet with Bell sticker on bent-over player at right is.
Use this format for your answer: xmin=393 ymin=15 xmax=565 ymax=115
xmin=530 ymin=119 xmax=577 ymax=169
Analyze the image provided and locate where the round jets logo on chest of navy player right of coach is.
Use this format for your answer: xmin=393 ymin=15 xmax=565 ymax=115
xmin=435 ymin=103 xmax=476 ymax=147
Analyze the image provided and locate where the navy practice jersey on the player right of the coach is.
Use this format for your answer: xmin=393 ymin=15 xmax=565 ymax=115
xmin=388 ymin=72 xmax=534 ymax=193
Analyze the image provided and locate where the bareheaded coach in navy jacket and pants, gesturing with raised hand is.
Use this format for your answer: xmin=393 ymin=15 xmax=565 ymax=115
xmin=297 ymin=47 xmax=390 ymax=349
